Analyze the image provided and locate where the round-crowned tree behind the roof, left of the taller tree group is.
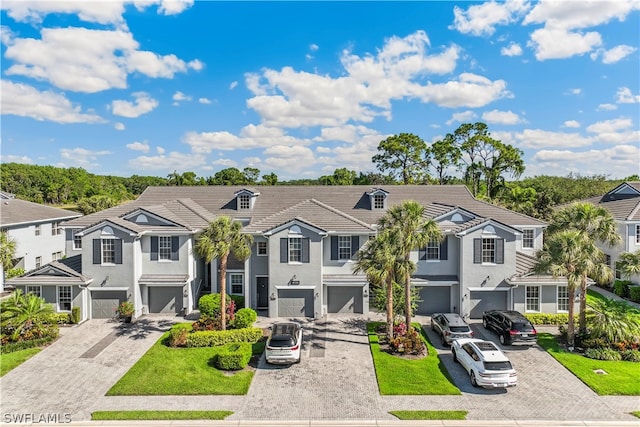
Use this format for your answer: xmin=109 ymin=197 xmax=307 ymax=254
xmin=372 ymin=133 xmax=429 ymax=184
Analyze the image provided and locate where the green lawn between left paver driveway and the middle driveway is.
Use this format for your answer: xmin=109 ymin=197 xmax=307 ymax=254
xmin=107 ymin=332 xmax=264 ymax=396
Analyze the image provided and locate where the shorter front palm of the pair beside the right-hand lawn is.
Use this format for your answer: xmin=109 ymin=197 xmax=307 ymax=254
xmin=535 ymin=229 xmax=612 ymax=347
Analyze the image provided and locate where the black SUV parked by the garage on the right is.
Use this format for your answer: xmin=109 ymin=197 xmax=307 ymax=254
xmin=482 ymin=310 xmax=538 ymax=345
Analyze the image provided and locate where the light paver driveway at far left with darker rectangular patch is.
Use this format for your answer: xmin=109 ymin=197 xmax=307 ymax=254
xmin=0 ymin=317 xmax=175 ymax=421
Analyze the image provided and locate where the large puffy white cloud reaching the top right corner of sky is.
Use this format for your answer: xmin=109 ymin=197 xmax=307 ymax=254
xmin=523 ymin=0 xmax=640 ymax=61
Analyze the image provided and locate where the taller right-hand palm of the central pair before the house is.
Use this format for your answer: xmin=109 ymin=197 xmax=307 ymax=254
xmin=379 ymin=200 xmax=442 ymax=330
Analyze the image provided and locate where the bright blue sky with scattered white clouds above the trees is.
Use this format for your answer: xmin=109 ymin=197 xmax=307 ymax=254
xmin=0 ymin=0 xmax=640 ymax=180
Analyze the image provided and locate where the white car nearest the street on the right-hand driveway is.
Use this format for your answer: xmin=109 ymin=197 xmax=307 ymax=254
xmin=451 ymin=338 xmax=518 ymax=388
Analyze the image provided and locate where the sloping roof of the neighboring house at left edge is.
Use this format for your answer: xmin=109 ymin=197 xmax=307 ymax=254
xmin=0 ymin=198 xmax=82 ymax=227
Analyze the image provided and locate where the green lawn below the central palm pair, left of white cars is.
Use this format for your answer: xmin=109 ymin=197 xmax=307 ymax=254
xmin=367 ymin=322 xmax=461 ymax=395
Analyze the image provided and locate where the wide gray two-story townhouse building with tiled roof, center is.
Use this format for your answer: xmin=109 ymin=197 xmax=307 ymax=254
xmin=6 ymin=185 xmax=570 ymax=318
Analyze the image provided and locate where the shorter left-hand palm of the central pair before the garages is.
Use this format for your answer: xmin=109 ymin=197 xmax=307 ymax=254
xmin=353 ymin=232 xmax=396 ymax=340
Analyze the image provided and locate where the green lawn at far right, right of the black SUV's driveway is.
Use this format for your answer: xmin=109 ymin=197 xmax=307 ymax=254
xmin=538 ymin=333 xmax=640 ymax=396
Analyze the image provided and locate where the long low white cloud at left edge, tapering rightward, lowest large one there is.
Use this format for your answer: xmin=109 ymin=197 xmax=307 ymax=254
xmin=0 ymin=80 xmax=104 ymax=123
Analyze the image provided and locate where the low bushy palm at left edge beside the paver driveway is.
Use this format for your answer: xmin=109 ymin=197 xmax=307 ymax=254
xmin=0 ymin=289 xmax=53 ymax=341
